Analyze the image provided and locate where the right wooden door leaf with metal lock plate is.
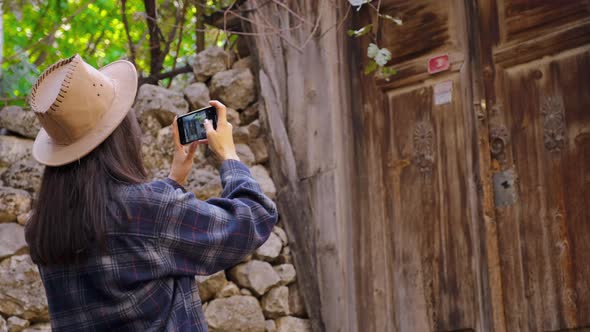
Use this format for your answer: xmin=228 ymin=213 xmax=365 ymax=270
xmin=480 ymin=0 xmax=590 ymax=332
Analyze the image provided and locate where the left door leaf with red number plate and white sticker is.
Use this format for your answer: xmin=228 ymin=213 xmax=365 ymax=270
xmin=352 ymin=0 xmax=488 ymax=332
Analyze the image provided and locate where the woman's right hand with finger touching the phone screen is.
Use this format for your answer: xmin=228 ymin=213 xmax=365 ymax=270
xmin=205 ymin=100 xmax=240 ymax=161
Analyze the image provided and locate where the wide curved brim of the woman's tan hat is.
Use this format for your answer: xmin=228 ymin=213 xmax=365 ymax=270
xmin=32 ymin=60 xmax=137 ymax=166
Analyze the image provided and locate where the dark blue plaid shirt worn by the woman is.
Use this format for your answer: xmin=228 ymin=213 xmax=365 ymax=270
xmin=39 ymin=160 xmax=277 ymax=331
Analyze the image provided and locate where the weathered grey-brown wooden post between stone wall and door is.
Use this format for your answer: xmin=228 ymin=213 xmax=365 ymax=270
xmin=244 ymin=0 xmax=357 ymax=331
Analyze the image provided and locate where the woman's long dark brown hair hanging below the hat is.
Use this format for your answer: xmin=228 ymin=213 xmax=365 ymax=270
xmin=25 ymin=111 xmax=147 ymax=265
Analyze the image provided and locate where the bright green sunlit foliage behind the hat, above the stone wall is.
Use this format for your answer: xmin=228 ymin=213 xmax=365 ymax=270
xmin=0 ymin=0 xmax=237 ymax=105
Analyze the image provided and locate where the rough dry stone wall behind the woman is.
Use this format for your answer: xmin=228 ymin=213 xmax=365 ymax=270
xmin=0 ymin=48 xmax=311 ymax=332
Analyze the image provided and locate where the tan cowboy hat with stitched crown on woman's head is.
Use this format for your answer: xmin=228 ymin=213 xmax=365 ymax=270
xmin=29 ymin=55 xmax=137 ymax=166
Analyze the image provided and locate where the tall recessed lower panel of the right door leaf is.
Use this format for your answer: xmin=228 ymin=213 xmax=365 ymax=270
xmin=495 ymin=47 xmax=590 ymax=331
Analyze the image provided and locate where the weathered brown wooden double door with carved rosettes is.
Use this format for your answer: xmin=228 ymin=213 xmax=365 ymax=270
xmin=352 ymin=0 xmax=590 ymax=331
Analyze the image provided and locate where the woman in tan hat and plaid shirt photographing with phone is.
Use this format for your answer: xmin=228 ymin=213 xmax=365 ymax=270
xmin=26 ymin=55 xmax=277 ymax=331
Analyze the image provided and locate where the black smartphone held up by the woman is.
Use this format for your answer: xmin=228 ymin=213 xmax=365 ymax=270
xmin=177 ymin=106 xmax=217 ymax=145
